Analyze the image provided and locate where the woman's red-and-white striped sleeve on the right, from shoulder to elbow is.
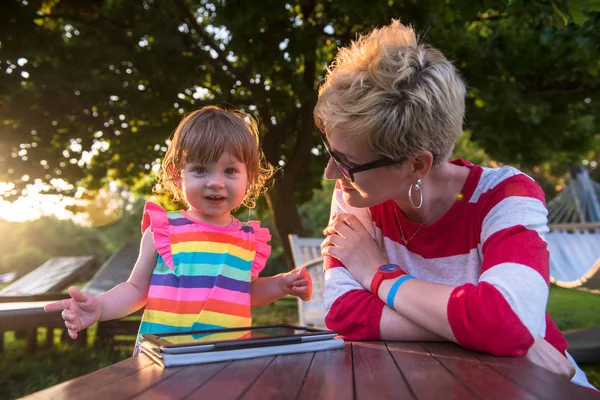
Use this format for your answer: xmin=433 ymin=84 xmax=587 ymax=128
xmin=448 ymin=167 xmax=549 ymax=356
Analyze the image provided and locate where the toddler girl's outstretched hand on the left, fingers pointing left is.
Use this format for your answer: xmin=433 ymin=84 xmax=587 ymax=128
xmin=44 ymin=286 xmax=102 ymax=339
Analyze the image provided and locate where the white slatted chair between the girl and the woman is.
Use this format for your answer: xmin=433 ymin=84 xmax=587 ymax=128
xmin=289 ymin=235 xmax=326 ymax=328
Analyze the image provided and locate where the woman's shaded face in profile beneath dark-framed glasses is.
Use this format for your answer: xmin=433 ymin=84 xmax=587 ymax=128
xmin=324 ymin=129 xmax=409 ymax=208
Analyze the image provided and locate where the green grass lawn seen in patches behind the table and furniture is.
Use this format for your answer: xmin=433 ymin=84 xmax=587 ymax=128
xmin=0 ymin=286 xmax=600 ymax=400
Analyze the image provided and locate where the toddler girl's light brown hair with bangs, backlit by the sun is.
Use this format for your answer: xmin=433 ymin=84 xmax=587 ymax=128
xmin=158 ymin=106 xmax=275 ymax=208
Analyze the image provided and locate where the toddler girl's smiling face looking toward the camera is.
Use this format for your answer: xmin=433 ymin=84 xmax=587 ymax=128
xmin=177 ymin=151 xmax=249 ymax=226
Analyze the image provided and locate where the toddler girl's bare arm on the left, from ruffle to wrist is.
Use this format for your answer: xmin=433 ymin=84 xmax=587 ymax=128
xmin=97 ymin=229 xmax=156 ymax=321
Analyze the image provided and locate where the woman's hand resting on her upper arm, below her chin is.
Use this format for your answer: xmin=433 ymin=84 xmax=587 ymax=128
xmin=321 ymin=214 xmax=389 ymax=290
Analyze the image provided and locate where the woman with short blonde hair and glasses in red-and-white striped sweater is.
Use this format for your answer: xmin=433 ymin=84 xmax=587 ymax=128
xmin=314 ymin=21 xmax=591 ymax=387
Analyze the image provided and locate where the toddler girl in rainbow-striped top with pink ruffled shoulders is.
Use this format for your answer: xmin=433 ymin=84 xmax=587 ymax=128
xmin=45 ymin=106 xmax=312 ymax=353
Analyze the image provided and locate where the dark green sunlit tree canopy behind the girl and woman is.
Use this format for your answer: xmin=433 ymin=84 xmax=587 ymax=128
xmin=0 ymin=0 xmax=600 ymax=262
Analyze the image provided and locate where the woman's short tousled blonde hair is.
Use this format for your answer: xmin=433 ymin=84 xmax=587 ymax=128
xmin=314 ymin=20 xmax=466 ymax=165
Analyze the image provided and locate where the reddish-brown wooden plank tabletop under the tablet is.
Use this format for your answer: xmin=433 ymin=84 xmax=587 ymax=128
xmin=22 ymin=342 xmax=600 ymax=400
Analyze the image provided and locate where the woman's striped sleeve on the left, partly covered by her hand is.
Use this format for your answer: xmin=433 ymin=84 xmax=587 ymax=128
xmin=323 ymin=183 xmax=384 ymax=340
